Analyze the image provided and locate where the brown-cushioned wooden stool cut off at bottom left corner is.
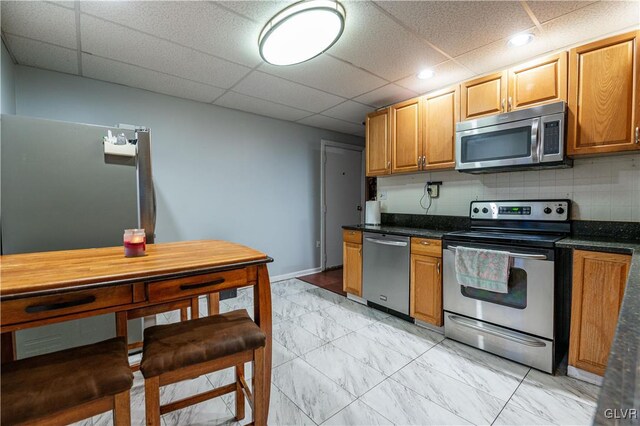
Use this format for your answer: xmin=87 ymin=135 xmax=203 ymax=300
xmin=0 ymin=337 xmax=133 ymax=426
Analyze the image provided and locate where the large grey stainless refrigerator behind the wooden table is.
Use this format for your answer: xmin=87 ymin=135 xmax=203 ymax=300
xmin=1 ymin=115 xmax=155 ymax=358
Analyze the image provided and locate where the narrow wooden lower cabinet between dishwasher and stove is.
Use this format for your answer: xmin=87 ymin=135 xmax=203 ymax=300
xmin=409 ymin=238 xmax=442 ymax=327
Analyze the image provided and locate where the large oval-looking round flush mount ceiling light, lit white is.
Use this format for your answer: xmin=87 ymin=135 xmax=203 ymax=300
xmin=258 ymin=0 xmax=345 ymax=65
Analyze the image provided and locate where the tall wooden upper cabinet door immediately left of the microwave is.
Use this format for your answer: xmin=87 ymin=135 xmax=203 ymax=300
xmin=422 ymin=86 xmax=460 ymax=170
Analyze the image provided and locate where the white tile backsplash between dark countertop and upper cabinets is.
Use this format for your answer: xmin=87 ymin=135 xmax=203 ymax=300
xmin=378 ymin=154 xmax=640 ymax=222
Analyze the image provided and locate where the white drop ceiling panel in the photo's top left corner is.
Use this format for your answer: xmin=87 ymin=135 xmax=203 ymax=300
xmin=0 ymin=1 xmax=77 ymax=49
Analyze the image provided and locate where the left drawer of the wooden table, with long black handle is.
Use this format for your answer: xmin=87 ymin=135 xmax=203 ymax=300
xmin=1 ymin=285 xmax=133 ymax=324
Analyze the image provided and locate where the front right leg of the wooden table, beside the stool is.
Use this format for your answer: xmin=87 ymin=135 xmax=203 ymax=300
xmin=253 ymin=265 xmax=272 ymax=423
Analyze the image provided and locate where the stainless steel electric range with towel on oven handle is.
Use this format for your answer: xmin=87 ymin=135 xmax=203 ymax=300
xmin=443 ymin=200 xmax=571 ymax=373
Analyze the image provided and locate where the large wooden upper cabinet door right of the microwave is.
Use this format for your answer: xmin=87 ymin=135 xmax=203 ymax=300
xmin=567 ymin=31 xmax=640 ymax=155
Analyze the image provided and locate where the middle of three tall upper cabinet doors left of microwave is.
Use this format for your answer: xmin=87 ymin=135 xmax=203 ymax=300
xmin=390 ymin=98 xmax=422 ymax=173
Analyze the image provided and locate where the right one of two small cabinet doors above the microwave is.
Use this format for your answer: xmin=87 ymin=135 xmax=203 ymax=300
xmin=507 ymin=52 xmax=568 ymax=111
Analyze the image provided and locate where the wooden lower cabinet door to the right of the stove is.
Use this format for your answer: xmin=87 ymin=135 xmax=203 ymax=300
xmin=569 ymin=250 xmax=631 ymax=376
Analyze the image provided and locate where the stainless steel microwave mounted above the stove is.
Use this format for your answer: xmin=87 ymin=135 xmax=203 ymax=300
xmin=456 ymin=101 xmax=573 ymax=173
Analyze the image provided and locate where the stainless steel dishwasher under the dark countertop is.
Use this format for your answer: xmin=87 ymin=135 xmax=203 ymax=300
xmin=362 ymin=232 xmax=410 ymax=315
